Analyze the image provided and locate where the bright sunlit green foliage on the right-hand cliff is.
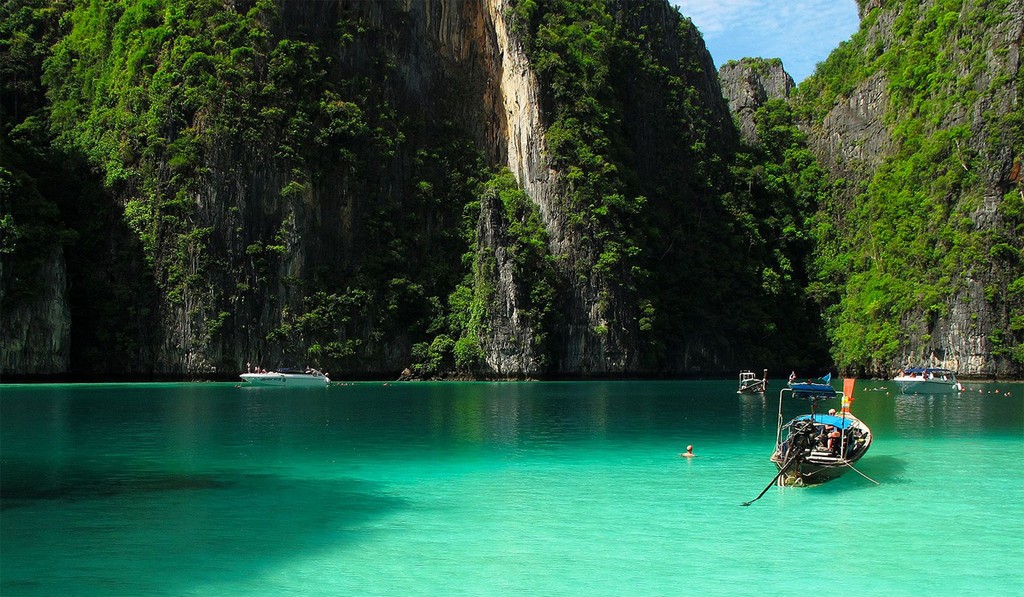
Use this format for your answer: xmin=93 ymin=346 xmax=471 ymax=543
xmin=794 ymin=0 xmax=1024 ymax=372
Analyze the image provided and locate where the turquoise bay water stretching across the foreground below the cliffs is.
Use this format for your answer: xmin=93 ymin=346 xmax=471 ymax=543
xmin=0 ymin=381 xmax=1024 ymax=597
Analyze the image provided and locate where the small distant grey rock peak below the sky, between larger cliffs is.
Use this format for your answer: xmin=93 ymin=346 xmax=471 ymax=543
xmin=718 ymin=58 xmax=795 ymax=143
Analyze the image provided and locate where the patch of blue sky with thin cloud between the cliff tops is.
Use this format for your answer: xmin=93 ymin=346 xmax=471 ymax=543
xmin=672 ymin=0 xmax=859 ymax=83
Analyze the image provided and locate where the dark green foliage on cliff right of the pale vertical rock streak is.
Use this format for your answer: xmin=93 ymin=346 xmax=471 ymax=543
xmin=513 ymin=0 xmax=823 ymax=369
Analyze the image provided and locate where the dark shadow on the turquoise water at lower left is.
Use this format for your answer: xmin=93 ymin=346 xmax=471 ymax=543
xmin=0 ymin=469 xmax=408 ymax=594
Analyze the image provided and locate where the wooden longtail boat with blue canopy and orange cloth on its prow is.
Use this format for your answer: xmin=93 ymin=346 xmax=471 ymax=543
xmin=771 ymin=378 xmax=872 ymax=485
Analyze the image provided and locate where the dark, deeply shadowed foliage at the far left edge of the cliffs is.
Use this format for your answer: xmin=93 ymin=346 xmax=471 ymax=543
xmin=0 ymin=1 xmax=159 ymax=364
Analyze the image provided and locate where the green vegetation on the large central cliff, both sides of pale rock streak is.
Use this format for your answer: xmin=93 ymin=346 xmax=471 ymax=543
xmin=4 ymin=0 xmax=831 ymax=375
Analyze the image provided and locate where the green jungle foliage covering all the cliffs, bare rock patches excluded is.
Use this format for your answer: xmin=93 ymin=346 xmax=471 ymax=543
xmin=0 ymin=0 xmax=1024 ymax=377
